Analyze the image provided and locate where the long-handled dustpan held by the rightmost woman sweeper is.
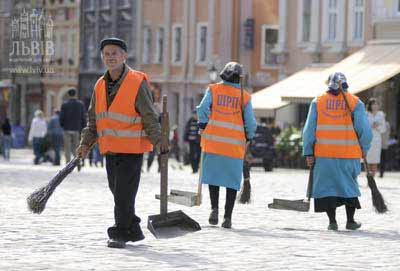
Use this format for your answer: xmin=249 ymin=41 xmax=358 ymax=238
xmin=268 ymin=167 xmax=314 ymax=212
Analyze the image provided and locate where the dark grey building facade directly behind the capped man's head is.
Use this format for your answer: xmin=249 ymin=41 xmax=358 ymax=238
xmin=78 ymin=0 xmax=138 ymax=109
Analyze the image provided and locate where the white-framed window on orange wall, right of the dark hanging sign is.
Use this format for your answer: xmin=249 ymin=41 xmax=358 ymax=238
xmin=261 ymin=25 xmax=278 ymax=66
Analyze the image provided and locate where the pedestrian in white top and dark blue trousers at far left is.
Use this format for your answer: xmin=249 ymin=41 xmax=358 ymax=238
xmin=28 ymin=110 xmax=47 ymax=165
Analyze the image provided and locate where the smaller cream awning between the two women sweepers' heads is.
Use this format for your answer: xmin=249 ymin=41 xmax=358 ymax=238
xmin=251 ymin=66 xmax=326 ymax=117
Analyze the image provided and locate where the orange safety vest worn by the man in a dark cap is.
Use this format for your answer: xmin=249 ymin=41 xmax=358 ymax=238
xmin=95 ymin=69 xmax=153 ymax=154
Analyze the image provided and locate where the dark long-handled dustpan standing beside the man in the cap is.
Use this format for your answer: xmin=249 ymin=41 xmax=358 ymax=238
xmin=147 ymin=95 xmax=201 ymax=238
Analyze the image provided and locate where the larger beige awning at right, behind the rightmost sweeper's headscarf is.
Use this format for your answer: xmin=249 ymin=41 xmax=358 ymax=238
xmin=282 ymin=40 xmax=400 ymax=103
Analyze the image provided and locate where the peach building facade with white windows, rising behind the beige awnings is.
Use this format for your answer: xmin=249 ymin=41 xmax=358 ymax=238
xmin=275 ymin=0 xmax=373 ymax=126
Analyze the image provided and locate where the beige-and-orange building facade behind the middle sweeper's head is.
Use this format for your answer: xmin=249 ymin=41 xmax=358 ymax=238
xmin=136 ymin=0 xmax=282 ymax=144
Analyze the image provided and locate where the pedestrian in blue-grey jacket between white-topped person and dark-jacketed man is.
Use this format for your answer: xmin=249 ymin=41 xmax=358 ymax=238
xmin=47 ymin=110 xmax=64 ymax=166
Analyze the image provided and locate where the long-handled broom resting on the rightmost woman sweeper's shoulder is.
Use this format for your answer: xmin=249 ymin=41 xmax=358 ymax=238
xmin=339 ymin=89 xmax=388 ymax=213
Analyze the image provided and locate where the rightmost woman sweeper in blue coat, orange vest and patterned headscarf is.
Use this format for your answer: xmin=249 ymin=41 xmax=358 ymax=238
xmin=303 ymin=72 xmax=372 ymax=230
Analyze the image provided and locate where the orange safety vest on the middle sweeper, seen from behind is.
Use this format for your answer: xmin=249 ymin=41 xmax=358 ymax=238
xmin=201 ymin=83 xmax=250 ymax=159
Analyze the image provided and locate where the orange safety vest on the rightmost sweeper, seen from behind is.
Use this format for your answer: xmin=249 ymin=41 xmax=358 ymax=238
xmin=314 ymin=92 xmax=362 ymax=158
